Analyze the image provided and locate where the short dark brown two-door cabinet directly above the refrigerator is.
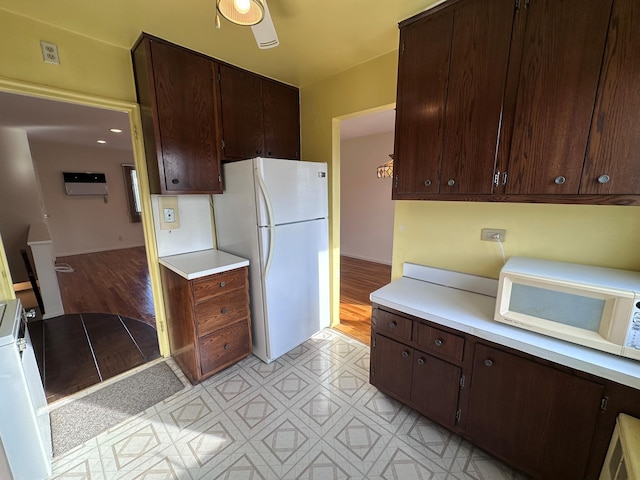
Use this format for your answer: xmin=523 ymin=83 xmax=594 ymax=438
xmin=219 ymin=65 xmax=300 ymax=160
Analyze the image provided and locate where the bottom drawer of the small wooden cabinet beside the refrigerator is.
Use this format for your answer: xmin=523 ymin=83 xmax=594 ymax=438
xmin=198 ymin=321 xmax=251 ymax=375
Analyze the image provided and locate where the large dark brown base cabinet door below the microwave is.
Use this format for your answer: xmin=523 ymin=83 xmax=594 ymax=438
xmin=463 ymin=344 xmax=603 ymax=480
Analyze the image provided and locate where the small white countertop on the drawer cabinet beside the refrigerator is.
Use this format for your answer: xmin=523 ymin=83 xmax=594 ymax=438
xmin=158 ymin=248 xmax=249 ymax=280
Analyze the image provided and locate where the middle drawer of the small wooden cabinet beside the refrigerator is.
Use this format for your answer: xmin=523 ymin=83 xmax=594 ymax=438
xmin=195 ymin=289 xmax=249 ymax=337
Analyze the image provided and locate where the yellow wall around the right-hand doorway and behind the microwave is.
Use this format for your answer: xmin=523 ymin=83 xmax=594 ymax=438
xmin=301 ymin=47 xmax=640 ymax=323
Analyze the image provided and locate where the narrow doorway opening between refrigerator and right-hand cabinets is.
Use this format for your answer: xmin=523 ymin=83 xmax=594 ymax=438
xmin=335 ymin=106 xmax=395 ymax=344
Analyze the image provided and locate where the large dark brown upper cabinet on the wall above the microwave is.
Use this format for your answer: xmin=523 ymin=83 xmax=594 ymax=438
xmin=393 ymin=0 xmax=640 ymax=205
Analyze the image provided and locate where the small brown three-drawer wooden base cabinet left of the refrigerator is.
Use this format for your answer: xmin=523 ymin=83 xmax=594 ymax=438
xmin=160 ymin=266 xmax=251 ymax=384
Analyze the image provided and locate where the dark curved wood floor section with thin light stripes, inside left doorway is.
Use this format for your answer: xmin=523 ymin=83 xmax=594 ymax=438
xmin=28 ymin=313 xmax=160 ymax=403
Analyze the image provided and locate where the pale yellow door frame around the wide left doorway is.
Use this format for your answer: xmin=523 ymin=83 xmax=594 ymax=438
xmin=0 ymin=77 xmax=171 ymax=357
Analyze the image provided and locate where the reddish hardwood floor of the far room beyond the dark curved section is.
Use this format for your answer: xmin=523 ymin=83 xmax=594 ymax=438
xmin=56 ymin=247 xmax=156 ymax=327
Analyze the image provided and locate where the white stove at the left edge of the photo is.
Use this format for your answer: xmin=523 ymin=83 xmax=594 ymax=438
xmin=0 ymin=300 xmax=52 ymax=480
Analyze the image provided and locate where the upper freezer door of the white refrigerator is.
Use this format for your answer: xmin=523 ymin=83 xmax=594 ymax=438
xmin=254 ymin=158 xmax=328 ymax=226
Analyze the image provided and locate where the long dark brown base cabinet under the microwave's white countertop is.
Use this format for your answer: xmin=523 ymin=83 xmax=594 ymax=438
xmin=369 ymin=304 xmax=640 ymax=480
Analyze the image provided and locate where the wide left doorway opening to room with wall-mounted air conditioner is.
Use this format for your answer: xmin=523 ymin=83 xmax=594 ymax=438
xmin=0 ymin=85 xmax=166 ymax=400
